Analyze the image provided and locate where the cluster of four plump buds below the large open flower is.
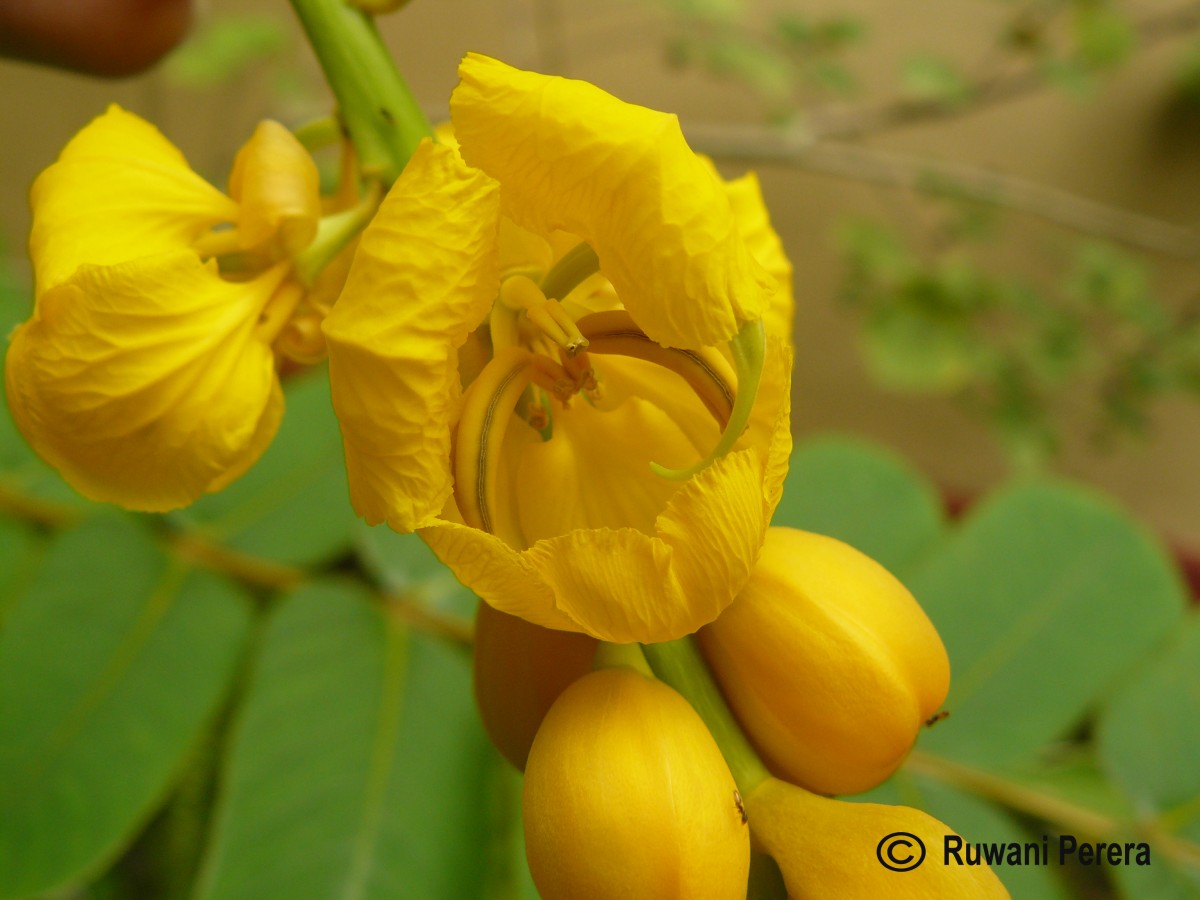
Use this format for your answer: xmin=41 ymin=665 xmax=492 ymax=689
xmin=475 ymin=528 xmax=1008 ymax=900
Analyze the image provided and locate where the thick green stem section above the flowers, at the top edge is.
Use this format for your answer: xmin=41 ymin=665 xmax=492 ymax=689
xmin=285 ymin=0 xmax=433 ymax=184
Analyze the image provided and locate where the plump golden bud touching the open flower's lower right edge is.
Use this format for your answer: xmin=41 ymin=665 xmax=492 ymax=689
xmin=697 ymin=528 xmax=950 ymax=794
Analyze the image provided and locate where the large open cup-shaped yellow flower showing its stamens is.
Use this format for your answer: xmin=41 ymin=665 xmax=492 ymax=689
xmin=324 ymin=55 xmax=792 ymax=642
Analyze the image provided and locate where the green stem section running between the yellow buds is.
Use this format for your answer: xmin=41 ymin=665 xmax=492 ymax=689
xmin=642 ymin=637 xmax=770 ymax=797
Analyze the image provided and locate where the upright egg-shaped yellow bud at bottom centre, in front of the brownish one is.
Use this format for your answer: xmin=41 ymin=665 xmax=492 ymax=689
xmin=523 ymin=668 xmax=750 ymax=900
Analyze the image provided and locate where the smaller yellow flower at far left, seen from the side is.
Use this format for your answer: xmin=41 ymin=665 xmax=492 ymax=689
xmin=5 ymin=106 xmax=320 ymax=511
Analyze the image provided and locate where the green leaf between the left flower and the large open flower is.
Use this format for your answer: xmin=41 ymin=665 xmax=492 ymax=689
xmin=173 ymin=372 xmax=358 ymax=566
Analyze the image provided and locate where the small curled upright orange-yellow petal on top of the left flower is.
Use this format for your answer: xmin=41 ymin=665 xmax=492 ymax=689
xmin=229 ymin=119 xmax=320 ymax=256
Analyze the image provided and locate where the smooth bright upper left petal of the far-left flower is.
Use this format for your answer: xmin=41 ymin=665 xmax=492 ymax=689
xmin=29 ymin=106 xmax=238 ymax=294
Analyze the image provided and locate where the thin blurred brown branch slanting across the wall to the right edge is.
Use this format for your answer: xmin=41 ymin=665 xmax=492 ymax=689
xmin=688 ymin=126 xmax=1200 ymax=262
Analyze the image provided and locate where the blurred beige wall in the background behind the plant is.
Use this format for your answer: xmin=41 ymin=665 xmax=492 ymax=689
xmin=0 ymin=0 xmax=1200 ymax=551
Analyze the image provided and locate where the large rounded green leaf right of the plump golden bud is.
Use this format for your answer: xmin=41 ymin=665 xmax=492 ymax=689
xmin=908 ymin=484 xmax=1184 ymax=767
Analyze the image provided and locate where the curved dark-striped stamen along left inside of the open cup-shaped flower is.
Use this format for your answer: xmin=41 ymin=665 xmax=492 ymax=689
xmin=454 ymin=347 xmax=535 ymax=547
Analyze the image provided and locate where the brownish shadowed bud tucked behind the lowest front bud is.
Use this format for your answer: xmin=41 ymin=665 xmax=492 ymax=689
xmin=474 ymin=604 xmax=599 ymax=769
